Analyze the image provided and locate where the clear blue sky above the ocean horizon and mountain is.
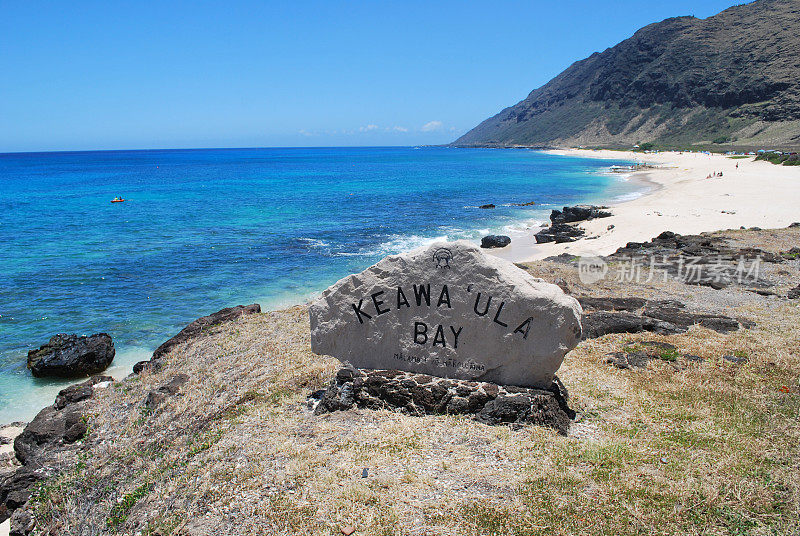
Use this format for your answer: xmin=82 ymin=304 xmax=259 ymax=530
xmin=0 ymin=0 xmax=740 ymax=152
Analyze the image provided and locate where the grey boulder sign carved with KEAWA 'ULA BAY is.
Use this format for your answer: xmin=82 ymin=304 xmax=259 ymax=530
xmin=309 ymin=241 xmax=581 ymax=387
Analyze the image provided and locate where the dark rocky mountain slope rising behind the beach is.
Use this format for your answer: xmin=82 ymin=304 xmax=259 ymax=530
xmin=454 ymin=0 xmax=800 ymax=147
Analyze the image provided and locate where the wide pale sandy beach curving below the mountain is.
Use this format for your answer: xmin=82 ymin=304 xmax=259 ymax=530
xmin=491 ymin=149 xmax=800 ymax=262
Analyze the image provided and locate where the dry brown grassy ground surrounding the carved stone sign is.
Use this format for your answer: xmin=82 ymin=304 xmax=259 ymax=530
xmin=21 ymin=231 xmax=800 ymax=535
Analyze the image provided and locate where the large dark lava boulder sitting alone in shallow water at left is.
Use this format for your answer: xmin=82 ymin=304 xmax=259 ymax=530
xmin=28 ymin=333 xmax=115 ymax=378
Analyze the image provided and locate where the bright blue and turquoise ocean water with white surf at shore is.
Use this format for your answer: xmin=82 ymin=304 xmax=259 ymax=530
xmin=0 ymin=148 xmax=632 ymax=423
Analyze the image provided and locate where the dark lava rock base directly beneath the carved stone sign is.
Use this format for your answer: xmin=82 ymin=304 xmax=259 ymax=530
xmin=309 ymin=365 xmax=575 ymax=435
